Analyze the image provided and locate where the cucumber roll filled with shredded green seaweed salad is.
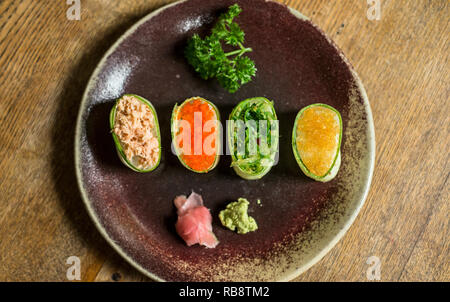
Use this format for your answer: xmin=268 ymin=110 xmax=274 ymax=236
xmin=228 ymin=97 xmax=279 ymax=180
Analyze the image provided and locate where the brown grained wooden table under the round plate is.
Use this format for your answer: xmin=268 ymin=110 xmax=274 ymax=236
xmin=0 ymin=0 xmax=450 ymax=281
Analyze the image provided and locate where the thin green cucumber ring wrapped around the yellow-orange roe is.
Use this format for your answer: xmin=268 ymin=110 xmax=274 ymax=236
xmin=292 ymin=103 xmax=342 ymax=182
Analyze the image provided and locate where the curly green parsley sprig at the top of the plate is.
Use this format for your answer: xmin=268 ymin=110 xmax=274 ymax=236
xmin=185 ymin=4 xmax=256 ymax=93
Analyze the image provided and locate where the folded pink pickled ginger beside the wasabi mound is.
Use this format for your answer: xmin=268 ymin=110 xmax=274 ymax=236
xmin=174 ymin=192 xmax=219 ymax=248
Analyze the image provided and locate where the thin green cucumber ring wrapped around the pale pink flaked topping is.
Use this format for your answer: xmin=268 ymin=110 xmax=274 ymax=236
xmin=109 ymin=94 xmax=161 ymax=173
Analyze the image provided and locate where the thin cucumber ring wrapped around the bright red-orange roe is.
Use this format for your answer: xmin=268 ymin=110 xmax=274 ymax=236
xmin=170 ymin=97 xmax=221 ymax=174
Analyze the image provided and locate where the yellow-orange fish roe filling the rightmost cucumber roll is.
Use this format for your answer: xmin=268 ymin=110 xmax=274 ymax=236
xmin=296 ymin=106 xmax=340 ymax=177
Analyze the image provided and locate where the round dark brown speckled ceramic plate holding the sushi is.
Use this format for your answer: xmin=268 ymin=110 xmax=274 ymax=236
xmin=75 ymin=0 xmax=374 ymax=281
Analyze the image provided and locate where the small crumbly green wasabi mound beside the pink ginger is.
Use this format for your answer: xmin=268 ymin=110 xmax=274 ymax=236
xmin=219 ymin=198 xmax=258 ymax=234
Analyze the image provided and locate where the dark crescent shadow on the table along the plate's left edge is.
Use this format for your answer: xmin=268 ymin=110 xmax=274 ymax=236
xmin=51 ymin=7 xmax=169 ymax=280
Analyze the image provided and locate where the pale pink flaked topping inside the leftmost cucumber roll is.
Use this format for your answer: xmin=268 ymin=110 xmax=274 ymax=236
xmin=114 ymin=95 xmax=159 ymax=170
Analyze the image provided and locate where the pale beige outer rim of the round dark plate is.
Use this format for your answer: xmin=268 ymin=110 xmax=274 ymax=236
xmin=74 ymin=0 xmax=376 ymax=282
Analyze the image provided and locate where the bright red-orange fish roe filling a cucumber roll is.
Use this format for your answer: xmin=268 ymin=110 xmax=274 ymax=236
xmin=176 ymin=98 xmax=217 ymax=172
